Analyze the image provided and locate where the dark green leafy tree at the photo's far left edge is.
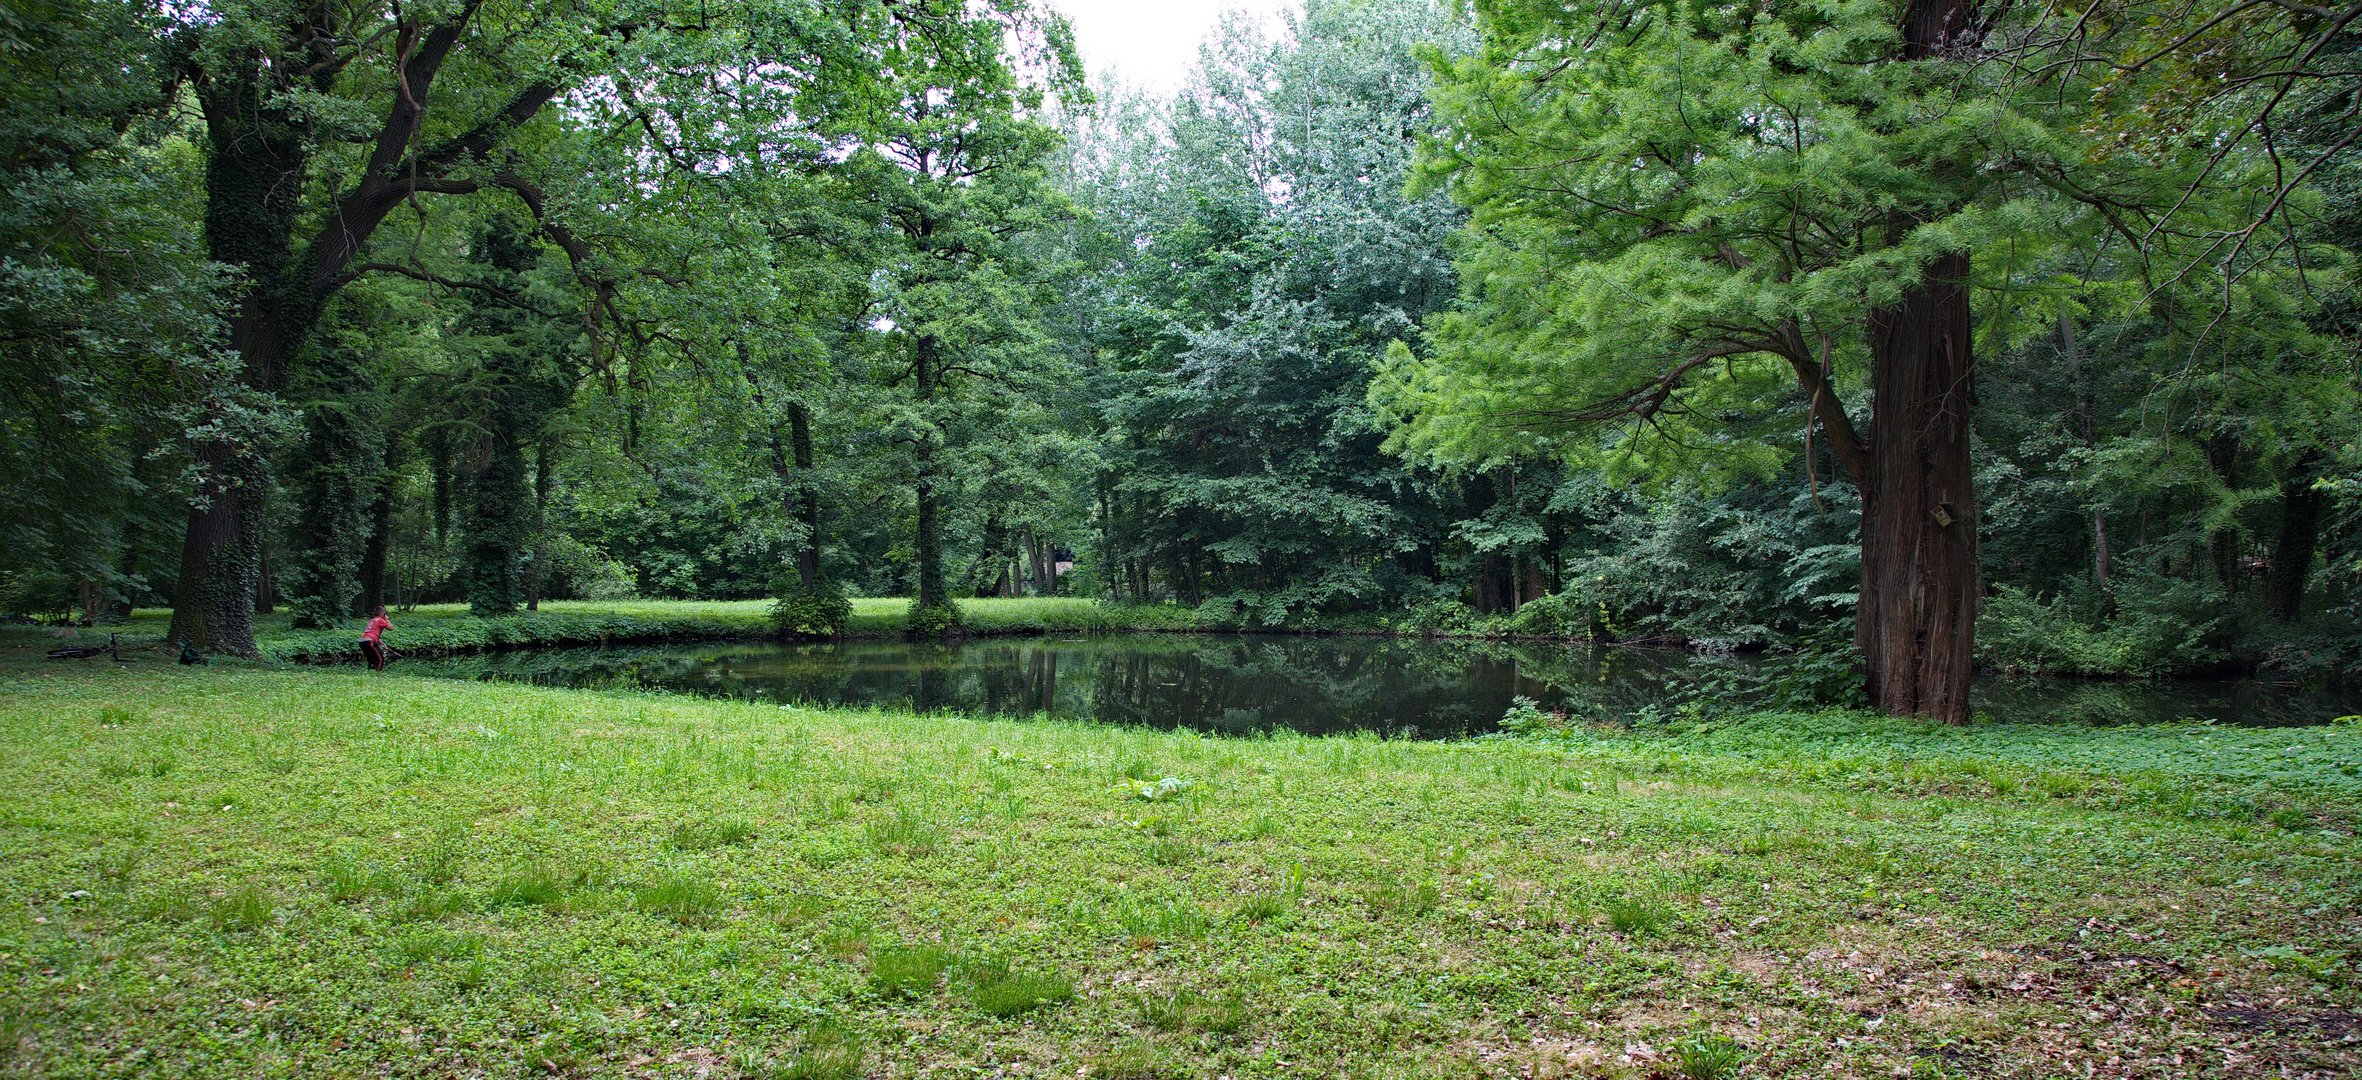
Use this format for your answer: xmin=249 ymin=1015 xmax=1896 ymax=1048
xmin=0 ymin=0 xmax=229 ymax=619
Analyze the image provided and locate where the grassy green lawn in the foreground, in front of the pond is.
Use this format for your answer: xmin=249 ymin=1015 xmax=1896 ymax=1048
xmin=0 ymin=647 xmax=2362 ymax=1078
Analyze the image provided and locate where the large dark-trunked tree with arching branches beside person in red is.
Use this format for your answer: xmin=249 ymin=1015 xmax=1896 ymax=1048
xmin=161 ymin=0 xmax=959 ymax=652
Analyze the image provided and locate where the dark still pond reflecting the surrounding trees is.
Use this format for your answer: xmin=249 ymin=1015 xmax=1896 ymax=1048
xmin=399 ymin=633 xmax=2362 ymax=737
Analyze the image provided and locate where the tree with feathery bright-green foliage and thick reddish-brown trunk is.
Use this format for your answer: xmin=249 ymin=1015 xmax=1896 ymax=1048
xmin=1375 ymin=0 xmax=2295 ymax=723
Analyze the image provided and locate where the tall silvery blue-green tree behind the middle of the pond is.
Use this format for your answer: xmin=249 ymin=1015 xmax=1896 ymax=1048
xmin=1070 ymin=0 xmax=1464 ymax=622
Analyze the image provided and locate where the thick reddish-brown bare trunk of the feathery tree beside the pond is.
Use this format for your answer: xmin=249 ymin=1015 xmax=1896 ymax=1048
xmin=1854 ymin=253 xmax=1977 ymax=723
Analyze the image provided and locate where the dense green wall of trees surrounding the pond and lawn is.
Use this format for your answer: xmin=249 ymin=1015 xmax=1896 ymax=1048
xmin=0 ymin=0 xmax=2362 ymax=711
